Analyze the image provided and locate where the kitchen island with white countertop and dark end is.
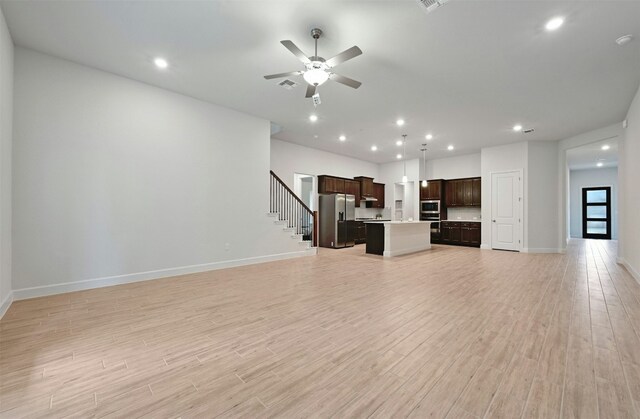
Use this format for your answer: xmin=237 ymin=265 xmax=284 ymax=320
xmin=364 ymin=221 xmax=431 ymax=257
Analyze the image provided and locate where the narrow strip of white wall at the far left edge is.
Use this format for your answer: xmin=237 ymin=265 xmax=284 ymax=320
xmin=0 ymin=9 xmax=14 ymax=317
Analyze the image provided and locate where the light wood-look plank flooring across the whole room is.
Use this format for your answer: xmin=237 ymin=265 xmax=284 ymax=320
xmin=0 ymin=240 xmax=640 ymax=418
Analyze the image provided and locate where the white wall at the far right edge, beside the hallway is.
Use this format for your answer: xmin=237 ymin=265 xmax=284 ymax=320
xmin=619 ymin=85 xmax=640 ymax=282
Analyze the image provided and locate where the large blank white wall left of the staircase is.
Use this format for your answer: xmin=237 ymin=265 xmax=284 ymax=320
xmin=11 ymin=48 xmax=300 ymax=291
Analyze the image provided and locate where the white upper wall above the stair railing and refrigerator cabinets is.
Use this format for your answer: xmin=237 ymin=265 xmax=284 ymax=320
xmin=271 ymin=139 xmax=380 ymax=188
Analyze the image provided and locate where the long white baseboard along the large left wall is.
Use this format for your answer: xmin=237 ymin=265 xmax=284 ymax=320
xmin=12 ymin=247 xmax=318 ymax=307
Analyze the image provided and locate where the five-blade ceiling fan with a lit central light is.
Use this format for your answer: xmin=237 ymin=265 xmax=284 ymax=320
xmin=264 ymin=28 xmax=362 ymax=97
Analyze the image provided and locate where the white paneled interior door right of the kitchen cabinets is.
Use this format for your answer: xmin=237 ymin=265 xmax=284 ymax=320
xmin=491 ymin=171 xmax=522 ymax=250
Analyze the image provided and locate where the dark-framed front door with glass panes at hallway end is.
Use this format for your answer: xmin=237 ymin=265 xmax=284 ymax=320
xmin=582 ymin=187 xmax=611 ymax=240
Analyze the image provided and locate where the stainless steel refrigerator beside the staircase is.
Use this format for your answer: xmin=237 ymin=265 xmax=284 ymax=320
xmin=318 ymin=194 xmax=356 ymax=249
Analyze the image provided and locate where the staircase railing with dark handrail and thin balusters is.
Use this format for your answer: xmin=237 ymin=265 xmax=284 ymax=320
xmin=269 ymin=170 xmax=318 ymax=248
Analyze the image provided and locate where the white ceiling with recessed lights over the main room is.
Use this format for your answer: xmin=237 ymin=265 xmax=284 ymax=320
xmin=0 ymin=0 xmax=640 ymax=162
